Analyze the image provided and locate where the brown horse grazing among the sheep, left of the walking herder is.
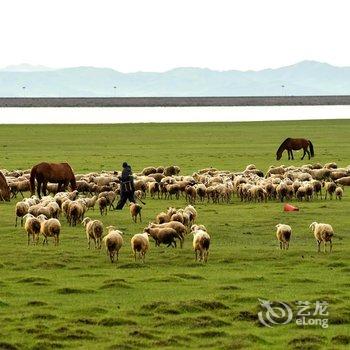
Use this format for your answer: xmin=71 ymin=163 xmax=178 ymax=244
xmin=30 ymin=162 xmax=77 ymax=198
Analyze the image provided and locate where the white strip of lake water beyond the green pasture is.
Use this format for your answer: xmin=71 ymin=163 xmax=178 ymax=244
xmin=0 ymin=106 xmax=350 ymax=124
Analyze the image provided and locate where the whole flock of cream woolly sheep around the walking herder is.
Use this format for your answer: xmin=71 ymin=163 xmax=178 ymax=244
xmin=1 ymin=163 xmax=344 ymax=262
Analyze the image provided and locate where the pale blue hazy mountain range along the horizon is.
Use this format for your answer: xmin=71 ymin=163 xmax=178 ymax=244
xmin=0 ymin=61 xmax=350 ymax=97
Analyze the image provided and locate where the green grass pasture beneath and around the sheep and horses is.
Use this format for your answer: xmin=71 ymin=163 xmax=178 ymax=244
xmin=0 ymin=120 xmax=350 ymax=349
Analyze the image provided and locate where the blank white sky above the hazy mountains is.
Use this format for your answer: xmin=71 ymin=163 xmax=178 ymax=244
xmin=0 ymin=0 xmax=350 ymax=72
